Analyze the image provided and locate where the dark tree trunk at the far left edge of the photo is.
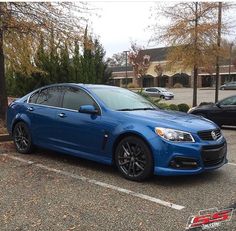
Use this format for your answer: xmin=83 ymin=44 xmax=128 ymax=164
xmin=0 ymin=28 xmax=7 ymax=119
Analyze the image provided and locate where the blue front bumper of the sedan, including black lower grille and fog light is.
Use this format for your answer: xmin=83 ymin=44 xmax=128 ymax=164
xmin=151 ymin=137 xmax=228 ymax=176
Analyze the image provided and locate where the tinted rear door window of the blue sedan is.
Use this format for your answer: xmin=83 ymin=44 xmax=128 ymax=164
xmin=36 ymin=87 xmax=62 ymax=107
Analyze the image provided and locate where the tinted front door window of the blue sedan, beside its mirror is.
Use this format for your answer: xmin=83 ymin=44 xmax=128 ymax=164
xmin=62 ymin=87 xmax=97 ymax=111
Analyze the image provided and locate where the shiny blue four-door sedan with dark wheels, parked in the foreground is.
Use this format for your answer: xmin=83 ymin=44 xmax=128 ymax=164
xmin=7 ymin=83 xmax=227 ymax=181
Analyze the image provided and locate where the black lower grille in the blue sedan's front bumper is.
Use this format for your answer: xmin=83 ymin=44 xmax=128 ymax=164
xmin=201 ymin=143 xmax=227 ymax=167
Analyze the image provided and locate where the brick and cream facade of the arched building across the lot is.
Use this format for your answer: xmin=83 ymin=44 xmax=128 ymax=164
xmin=110 ymin=47 xmax=236 ymax=88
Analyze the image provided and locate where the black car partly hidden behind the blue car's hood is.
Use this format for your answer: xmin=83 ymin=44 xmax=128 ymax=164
xmin=189 ymin=95 xmax=236 ymax=126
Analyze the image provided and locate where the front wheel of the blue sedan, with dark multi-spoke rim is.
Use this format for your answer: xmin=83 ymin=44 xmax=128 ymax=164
xmin=115 ymin=136 xmax=153 ymax=181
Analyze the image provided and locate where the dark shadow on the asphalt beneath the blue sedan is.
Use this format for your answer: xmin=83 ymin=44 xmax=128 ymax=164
xmin=32 ymin=149 xmax=222 ymax=187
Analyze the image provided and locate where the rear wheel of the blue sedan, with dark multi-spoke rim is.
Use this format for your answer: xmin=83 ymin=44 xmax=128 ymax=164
xmin=13 ymin=122 xmax=33 ymax=154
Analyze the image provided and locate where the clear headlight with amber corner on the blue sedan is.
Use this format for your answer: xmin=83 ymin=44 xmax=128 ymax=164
xmin=155 ymin=127 xmax=195 ymax=142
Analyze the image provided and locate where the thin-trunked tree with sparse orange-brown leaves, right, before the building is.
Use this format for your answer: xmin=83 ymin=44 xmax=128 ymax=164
xmin=151 ymin=2 xmax=232 ymax=106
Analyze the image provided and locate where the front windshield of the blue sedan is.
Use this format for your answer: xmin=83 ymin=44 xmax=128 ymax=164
xmin=92 ymin=88 xmax=156 ymax=111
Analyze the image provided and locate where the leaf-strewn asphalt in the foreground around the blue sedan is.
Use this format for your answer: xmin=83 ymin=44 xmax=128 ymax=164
xmin=0 ymin=128 xmax=236 ymax=231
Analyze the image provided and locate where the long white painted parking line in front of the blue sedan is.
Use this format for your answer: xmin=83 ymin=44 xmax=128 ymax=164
xmin=2 ymin=154 xmax=185 ymax=210
